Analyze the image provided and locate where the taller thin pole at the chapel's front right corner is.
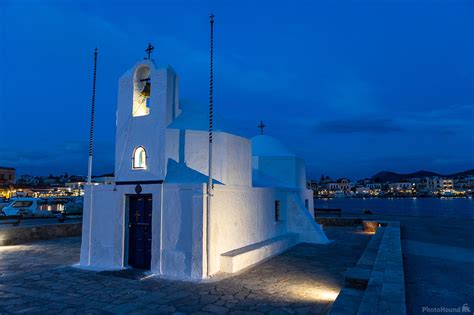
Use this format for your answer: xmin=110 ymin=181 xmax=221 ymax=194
xmin=206 ymin=14 xmax=214 ymax=276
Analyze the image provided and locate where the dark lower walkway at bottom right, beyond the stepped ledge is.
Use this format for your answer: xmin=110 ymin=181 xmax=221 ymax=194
xmin=401 ymin=218 xmax=474 ymax=314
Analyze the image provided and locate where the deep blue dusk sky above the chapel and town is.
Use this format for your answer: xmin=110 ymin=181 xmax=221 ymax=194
xmin=0 ymin=0 xmax=474 ymax=179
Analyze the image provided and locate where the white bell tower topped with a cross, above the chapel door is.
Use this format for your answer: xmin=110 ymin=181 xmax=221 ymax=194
xmin=115 ymin=45 xmax=180 ymax=182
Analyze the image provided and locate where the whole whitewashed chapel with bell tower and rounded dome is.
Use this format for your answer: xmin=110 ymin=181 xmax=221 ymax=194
xmin=80 ymin=55 xmax=328 ymax=280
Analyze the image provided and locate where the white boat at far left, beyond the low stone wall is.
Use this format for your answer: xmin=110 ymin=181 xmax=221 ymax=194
xmin=2 ymin=197 xmax=54 ymax=217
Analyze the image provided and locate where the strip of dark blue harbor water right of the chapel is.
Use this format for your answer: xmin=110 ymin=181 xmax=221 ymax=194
xmin=314 ymin=197 xmax=474 ymax=219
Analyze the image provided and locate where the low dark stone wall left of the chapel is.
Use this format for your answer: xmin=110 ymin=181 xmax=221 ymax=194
xmin=0 ymin=222 xmax=82 ymax=246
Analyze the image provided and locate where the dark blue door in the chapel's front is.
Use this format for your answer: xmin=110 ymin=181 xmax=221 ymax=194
xmin=128 ymin=195 xmax=152 ymax=269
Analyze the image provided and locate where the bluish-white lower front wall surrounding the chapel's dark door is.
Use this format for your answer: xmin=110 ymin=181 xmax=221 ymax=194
xmin=80 ymin=184 xmax=165 ymax=271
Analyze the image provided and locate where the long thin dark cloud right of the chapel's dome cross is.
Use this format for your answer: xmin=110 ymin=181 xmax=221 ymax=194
xmin=316 ymin=118 xmax=404 ymax=134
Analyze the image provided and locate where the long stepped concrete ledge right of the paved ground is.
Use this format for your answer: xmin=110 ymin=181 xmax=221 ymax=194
xmin=330 ymin=221 xmax=406 ymax=315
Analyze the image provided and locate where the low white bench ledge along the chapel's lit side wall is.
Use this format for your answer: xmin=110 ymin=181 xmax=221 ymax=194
xmin=221 ymin=233 xmax=298 ymax=273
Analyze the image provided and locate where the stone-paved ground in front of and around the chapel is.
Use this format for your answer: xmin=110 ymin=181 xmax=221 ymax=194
xmin=0 ymin=228 xmax=370 ymax=314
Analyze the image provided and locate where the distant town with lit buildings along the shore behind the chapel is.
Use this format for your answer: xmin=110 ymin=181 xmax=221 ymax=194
xmin=0 ymin=167 xmax=474 ymax=199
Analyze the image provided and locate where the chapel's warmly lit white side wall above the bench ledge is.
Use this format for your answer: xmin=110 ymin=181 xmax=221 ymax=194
xmin=210 ymin=185 xmax=327 ymax=274
